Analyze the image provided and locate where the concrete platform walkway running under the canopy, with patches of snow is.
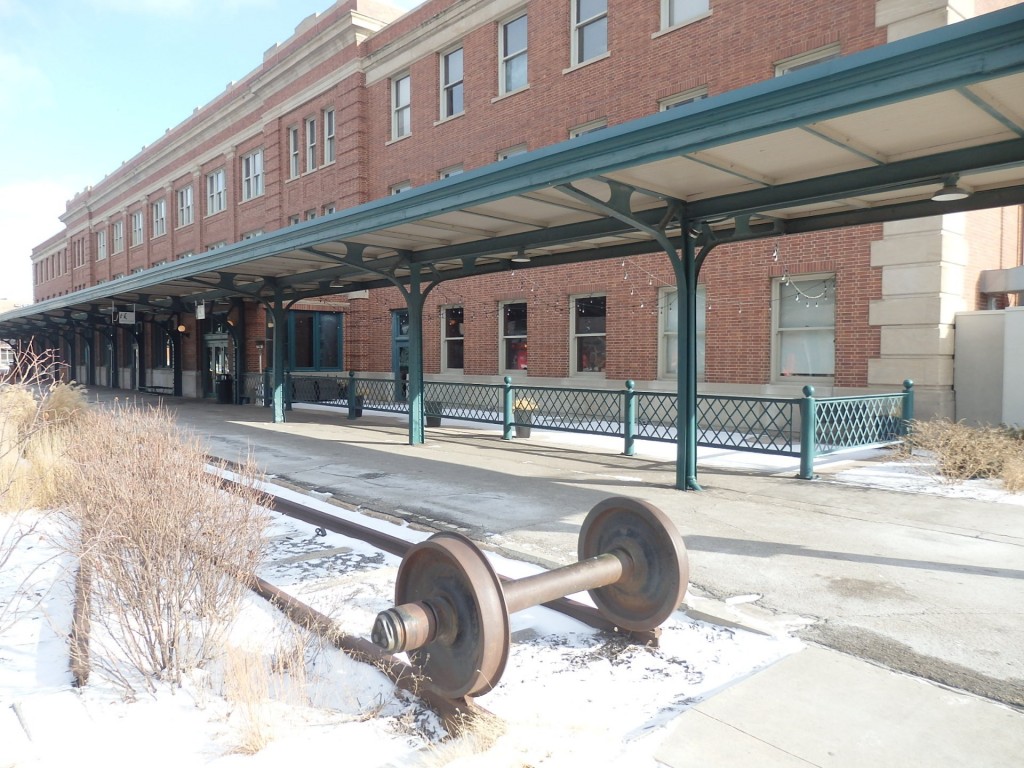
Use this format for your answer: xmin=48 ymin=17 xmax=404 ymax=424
xmin=93 ymin=390 xmax=1024 ymax=766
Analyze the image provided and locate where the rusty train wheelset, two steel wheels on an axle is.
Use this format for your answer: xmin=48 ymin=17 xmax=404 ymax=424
xmin=371 ymin=497 xmax=688 ymax=697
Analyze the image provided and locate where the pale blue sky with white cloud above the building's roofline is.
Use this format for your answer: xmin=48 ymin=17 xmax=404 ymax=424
xmin=0 ymin=0 xmax=421 ymax=303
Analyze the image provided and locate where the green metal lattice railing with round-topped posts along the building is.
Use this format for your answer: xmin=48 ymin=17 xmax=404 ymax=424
xmin=276 ymin=373 xmax=913 ymax=479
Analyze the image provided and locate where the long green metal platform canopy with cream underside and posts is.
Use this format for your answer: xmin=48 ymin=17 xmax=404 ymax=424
xmin=6 ymin=5 xmax=1024 ymax=487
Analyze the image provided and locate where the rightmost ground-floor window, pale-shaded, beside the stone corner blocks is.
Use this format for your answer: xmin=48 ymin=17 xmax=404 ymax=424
xmin=772 ymin=275 xmax=836 ymax=379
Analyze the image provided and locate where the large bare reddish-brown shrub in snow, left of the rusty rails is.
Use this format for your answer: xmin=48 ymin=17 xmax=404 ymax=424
xmin=62 ymin=406 xmax=267 ymax=693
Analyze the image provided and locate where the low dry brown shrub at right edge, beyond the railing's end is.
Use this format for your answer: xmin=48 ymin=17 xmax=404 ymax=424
xmin=908 ymin=420 xmax=1024 ymax=493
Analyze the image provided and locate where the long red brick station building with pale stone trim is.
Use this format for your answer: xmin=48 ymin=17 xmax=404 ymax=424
xmin=24 ymin=0 xmax=1022 ymax=416
